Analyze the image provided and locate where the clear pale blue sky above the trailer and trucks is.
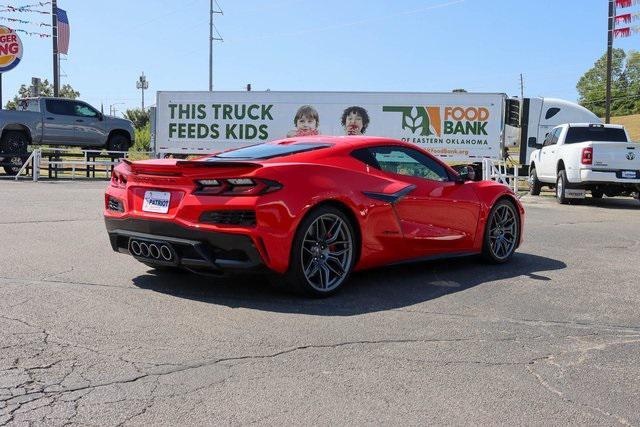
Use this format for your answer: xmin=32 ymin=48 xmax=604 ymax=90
xmin=0 ymin=0 xmax=640 ymax=111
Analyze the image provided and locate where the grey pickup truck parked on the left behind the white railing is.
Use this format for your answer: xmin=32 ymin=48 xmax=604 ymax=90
xmin=0 ymin=98 xmax=134 ymax=174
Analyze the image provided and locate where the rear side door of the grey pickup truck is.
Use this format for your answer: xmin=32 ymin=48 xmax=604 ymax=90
xmin=42 ymin=99 xmax=76 ymax=145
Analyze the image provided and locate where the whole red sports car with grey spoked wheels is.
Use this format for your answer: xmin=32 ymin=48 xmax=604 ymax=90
xmin=104 ymin=136 xmax=524 ymax=296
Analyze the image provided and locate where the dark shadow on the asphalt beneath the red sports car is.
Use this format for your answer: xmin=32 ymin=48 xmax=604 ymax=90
xmin=133 ymin=253 xmax=566 ymax=316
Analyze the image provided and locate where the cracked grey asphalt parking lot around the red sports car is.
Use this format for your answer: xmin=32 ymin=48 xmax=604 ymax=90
xmin=0 ymin=182 xmax=640 ymax=425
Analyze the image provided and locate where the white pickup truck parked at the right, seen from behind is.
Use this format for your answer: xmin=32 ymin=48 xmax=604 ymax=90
xmin=529 ymin=123 xmax=640 ymax=203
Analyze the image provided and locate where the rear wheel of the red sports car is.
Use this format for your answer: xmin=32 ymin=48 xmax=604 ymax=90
xmin=284 ymin=206 xmax=357 ymax=298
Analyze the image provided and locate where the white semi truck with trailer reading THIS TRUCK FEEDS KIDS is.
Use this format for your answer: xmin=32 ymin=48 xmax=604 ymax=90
xmin=152 ymin=91 xmax=600 ymax=168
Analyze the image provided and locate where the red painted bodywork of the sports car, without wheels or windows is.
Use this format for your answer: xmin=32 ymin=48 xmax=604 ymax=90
xmin=104 ymin=136 xmax=524 ymax=273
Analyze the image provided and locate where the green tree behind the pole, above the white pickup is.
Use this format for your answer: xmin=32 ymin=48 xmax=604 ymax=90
xmin=576 ymin=49 xmax=640 ymax=117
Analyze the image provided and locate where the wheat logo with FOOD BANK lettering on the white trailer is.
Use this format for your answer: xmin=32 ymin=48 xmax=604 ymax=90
xmin=382 ymin=105 xmax=489 ymax=138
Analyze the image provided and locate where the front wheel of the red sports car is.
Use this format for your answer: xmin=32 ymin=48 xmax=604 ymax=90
xmin=482 ymin=199 xmax=521 ymax=264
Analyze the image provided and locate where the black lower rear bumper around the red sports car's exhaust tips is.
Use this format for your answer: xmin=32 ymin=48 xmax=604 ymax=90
xmin=105 ymin=217 xmax=264 ymax=274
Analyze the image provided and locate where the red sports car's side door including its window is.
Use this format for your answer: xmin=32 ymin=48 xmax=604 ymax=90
xmin=370 ymin=146 xmax=480 ymax=256
